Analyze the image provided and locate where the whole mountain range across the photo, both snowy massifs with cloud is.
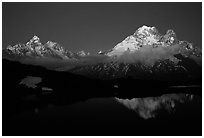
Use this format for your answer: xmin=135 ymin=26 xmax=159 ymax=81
xmin=3 ymin=26 xmax=202 ymax=80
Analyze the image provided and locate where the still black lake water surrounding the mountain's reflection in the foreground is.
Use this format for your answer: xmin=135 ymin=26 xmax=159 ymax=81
xmin=3 ymin=96 xmax=202 ymax=136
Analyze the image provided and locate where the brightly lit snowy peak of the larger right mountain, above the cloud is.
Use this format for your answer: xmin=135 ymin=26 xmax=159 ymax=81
xmin=107 ymin=25 xmax=177 ymax=56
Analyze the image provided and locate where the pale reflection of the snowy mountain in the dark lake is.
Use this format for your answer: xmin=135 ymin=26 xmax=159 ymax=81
xmin=115 ymin=94 xmax=194 ymax=119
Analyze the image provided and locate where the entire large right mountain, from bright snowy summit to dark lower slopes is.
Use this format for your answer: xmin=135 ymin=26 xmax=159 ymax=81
xmin=66 ymin=26 xmax=202 ymax=80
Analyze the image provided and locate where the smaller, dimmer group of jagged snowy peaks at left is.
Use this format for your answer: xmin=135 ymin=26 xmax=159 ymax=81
xmin=3 ymin=35 xmax=89 ymax=60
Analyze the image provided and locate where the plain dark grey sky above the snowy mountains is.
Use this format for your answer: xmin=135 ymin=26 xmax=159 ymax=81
xmin=2 ymin=2 xmax=202 ymax=53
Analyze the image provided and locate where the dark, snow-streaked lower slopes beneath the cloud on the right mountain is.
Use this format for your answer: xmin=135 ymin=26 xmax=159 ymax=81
xmin=69 ymin=55 xmax=202 ymax=81
